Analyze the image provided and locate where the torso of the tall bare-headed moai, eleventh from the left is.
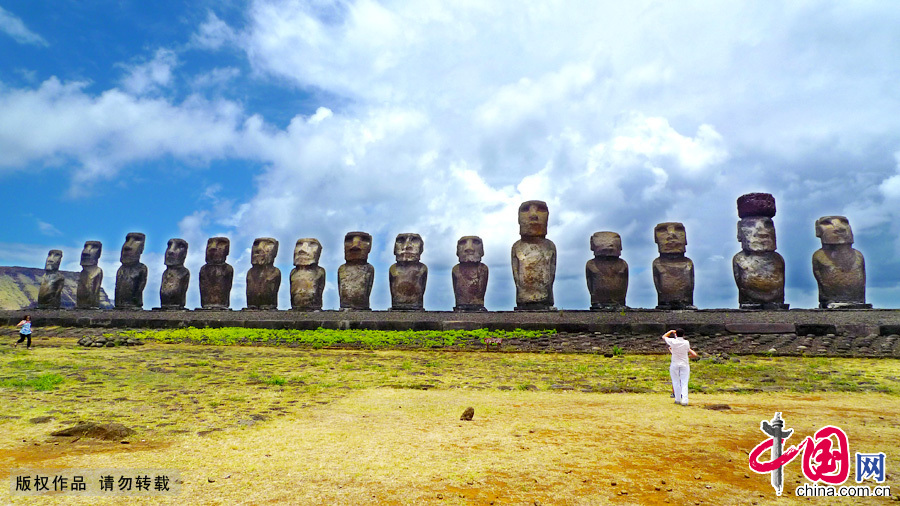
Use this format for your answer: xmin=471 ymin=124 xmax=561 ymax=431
xmin=511 ymin=238 xmax=556 ymax=308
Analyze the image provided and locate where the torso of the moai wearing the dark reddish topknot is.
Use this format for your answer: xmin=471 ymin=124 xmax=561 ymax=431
xmin=731 ymin=251 xmax=784 ymax=305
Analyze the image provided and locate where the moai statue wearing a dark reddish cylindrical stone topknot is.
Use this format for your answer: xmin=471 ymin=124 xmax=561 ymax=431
xmin=731 ymin=193 xmax=788 ymax=309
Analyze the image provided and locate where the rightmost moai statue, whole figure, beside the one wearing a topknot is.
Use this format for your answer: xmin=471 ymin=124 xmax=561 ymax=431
xmin=813 ymin=216 xmax=872 ymax=309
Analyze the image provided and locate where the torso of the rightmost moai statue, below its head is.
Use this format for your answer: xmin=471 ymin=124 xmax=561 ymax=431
xmin=813 ymin=248 xmax=866 ymax=308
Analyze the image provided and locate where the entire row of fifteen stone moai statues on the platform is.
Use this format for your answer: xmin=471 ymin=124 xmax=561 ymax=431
xmin=38 ymin=193 xmax=871 ymax=311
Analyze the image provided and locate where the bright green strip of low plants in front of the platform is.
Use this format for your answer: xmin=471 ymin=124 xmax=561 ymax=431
xmin=116 ymin=327 xmax=556 ymax=349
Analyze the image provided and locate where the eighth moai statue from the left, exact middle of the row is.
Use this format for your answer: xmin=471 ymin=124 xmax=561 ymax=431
xmin=338 ymin=232 xmax=375 ymax=310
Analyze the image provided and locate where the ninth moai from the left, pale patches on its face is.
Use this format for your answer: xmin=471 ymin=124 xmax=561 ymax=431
xmin=388 ymin=234 xmax=428 ymax=311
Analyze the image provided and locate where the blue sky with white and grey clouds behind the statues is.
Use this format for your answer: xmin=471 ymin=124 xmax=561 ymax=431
xmin=0 ymin=0 xmax=900 ymax=310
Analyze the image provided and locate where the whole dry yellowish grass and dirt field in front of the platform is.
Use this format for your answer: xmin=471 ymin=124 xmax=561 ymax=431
xmin=0 ymin=346 xmax=900 ymax=505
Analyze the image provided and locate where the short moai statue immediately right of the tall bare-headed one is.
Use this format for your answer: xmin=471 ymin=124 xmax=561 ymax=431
xmin=584 ymin=232 xmax=628 ymax=311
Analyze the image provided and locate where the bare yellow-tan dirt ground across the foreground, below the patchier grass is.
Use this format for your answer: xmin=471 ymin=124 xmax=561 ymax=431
xmin=0 ymin=388 xmax=900 ymax=505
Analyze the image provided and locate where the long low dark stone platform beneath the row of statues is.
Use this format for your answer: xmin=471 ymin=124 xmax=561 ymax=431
xmin=7 ymin=309 xmax=900 ymax=337
